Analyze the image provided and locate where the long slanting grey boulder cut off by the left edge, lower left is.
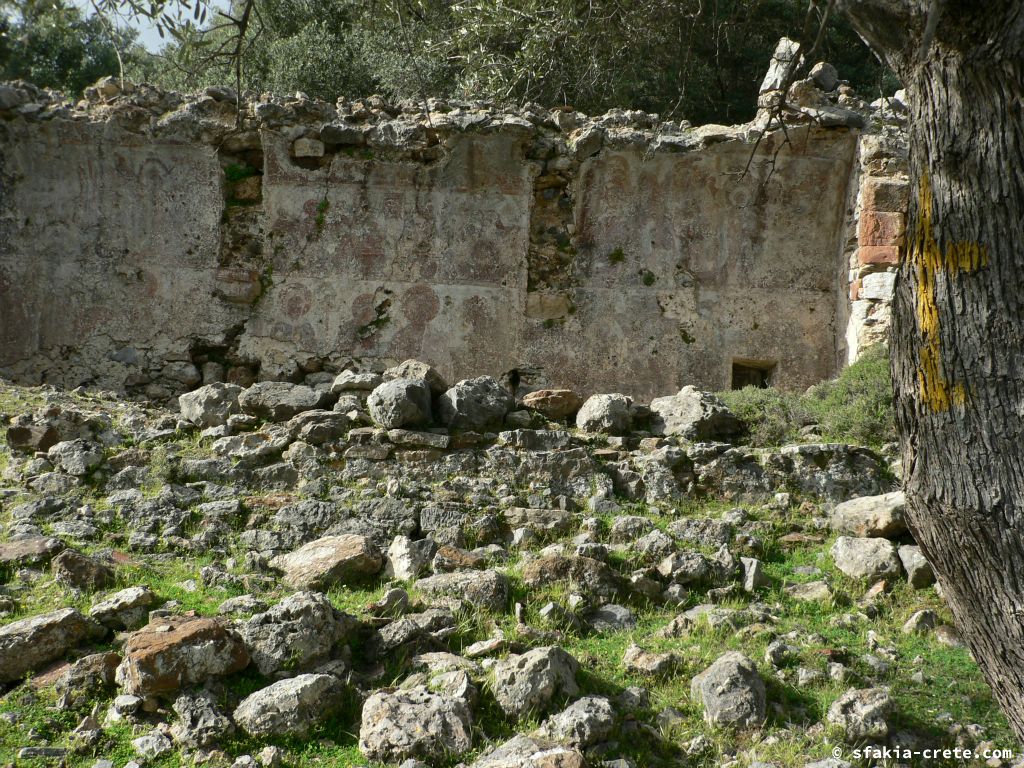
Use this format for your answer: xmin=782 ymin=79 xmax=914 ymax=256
xmin=0 ymin=608 xmax=104 ymax=683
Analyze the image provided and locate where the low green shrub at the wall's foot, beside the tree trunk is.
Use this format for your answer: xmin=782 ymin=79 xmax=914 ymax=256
xmin=719 ymin=345 xmax=896 ymax=446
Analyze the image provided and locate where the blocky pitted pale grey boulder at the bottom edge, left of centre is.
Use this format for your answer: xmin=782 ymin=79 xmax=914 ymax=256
xmin=359 ymin=688 xmax=473 ymax=763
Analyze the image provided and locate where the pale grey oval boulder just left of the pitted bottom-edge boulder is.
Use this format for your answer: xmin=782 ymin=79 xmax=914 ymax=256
xmin=233 ymin=675 xmax=344 ymax=736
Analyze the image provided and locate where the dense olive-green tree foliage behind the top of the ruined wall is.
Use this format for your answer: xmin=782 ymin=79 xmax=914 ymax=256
xmin=116 ymin=0 xmax=895 ymax=123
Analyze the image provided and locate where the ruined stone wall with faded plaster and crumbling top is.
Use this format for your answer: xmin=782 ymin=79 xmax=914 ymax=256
xmin=0 ymin=46 xmax=906 ymax=399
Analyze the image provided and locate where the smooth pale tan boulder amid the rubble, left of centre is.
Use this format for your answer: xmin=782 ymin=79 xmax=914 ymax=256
xmin=270 ymin=534 xmax=384 ymax=590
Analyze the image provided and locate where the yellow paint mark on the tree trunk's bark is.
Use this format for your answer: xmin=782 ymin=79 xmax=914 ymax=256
xmin=908 ymin=174 xmax=988 ymax=413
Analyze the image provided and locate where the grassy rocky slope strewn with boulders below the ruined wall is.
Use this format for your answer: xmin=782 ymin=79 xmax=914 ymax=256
xmin=0 ymin=361 xmax=1017 ymax=768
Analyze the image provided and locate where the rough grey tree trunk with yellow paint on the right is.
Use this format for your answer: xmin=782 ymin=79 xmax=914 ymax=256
xmin=839 ymin=0 xmax=1024 ymax=740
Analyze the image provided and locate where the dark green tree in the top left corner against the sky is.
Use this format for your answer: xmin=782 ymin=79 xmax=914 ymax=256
xmin=0 ymin=0 xmax=145 ymax=96
